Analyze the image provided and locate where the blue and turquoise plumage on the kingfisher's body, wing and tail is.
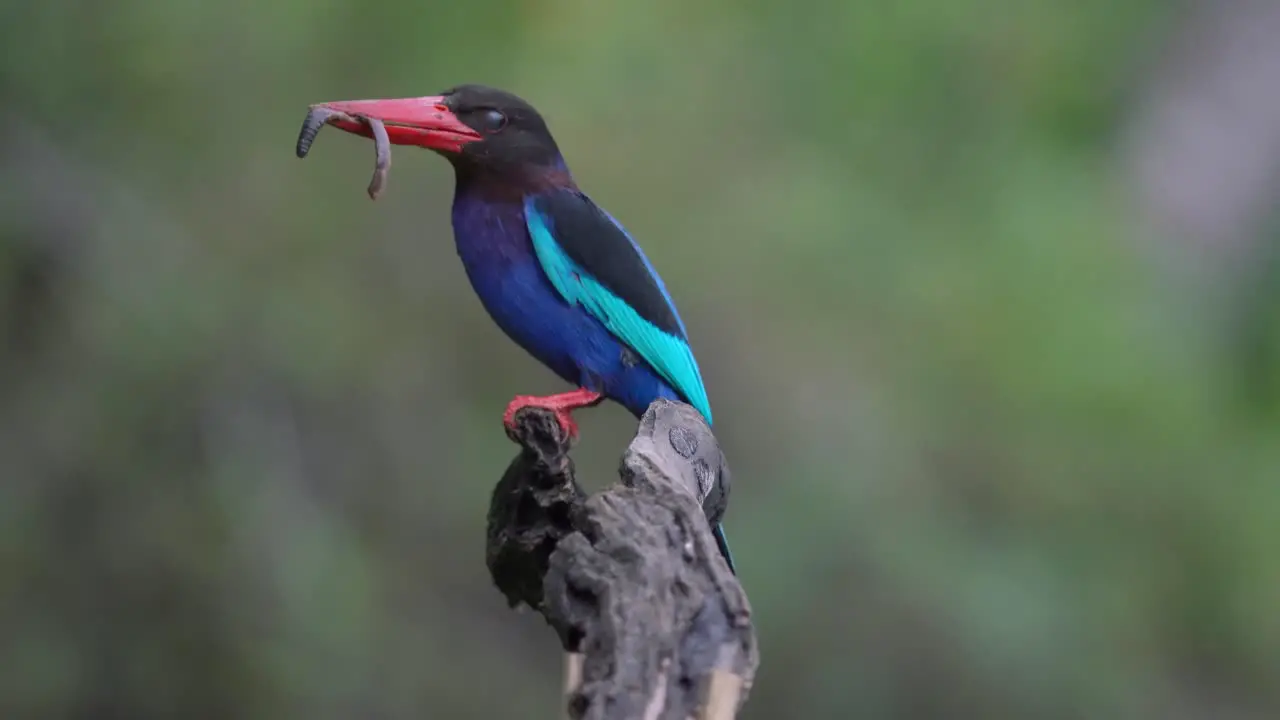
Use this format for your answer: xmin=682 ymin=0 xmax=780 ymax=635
xmin=453 ymin=188 xmax=733 ymax=569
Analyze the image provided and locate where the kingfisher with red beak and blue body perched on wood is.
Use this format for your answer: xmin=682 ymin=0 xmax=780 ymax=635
xmin=303 ymin=85 xmax=733 ymax=570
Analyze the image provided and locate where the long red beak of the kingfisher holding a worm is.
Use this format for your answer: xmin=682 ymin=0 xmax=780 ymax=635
xmin=312 ymin=95 xmax=483 ymax=152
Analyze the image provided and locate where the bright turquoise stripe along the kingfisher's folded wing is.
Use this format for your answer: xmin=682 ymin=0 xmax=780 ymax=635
xmin=525 ymin=199 xmax=712 ymax=424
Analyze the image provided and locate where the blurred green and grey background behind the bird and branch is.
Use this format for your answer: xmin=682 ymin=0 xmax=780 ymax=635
xmin=0 ymin=0 xmax=1280 ymax=720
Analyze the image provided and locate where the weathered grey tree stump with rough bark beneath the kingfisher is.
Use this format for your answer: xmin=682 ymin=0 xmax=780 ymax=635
xmin=488 ymin=400 xmax=759 ymax=720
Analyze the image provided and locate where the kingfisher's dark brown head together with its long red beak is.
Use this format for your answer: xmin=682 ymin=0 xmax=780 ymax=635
xmin=314 ymin=85 xmax=563 ymax=174
